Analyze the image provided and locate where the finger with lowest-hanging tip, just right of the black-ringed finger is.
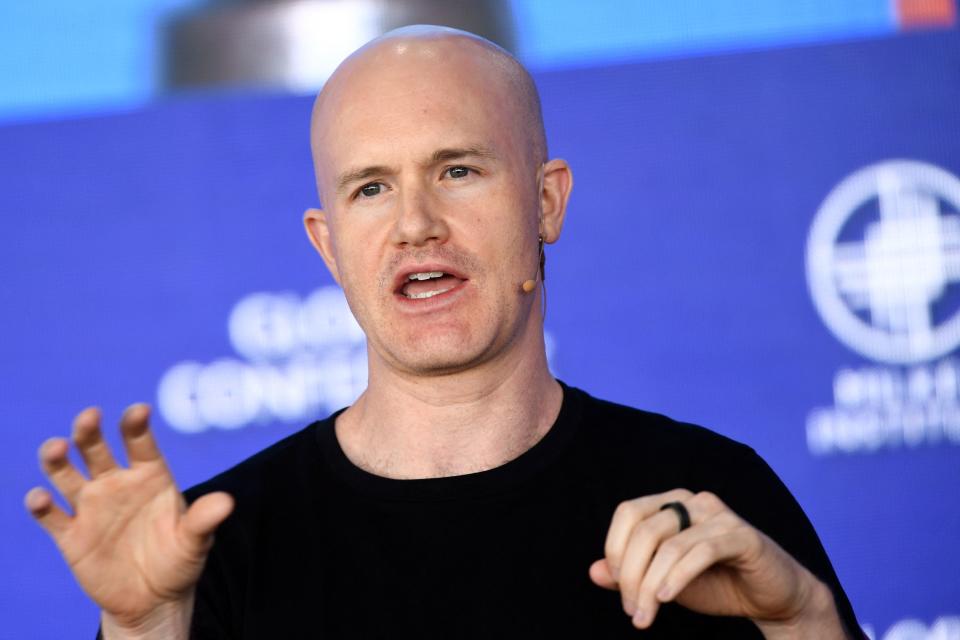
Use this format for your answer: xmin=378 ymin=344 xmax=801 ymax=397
xmin=633 ymin=518 xmax=728 ymax=629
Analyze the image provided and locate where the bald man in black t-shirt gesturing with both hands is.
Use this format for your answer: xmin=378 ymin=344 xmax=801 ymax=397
xmin=26 ymin=27 xmax=859 ymax=639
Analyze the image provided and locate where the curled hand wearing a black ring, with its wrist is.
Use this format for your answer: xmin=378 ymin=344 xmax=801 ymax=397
xmin=590 ymin=489 xmax=846 ymax=638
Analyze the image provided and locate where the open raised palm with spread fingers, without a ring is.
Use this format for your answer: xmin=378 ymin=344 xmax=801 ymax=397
xmin=24 ymin=404 xmax=233 ymax=637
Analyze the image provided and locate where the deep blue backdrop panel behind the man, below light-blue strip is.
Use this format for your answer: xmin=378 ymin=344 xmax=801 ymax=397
xmin=0 ymin=31 xmax=960 ymax=640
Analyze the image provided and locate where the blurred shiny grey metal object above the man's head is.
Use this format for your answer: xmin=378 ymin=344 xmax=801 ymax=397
xmin=163 ymin=0 xmax=514 ymax=91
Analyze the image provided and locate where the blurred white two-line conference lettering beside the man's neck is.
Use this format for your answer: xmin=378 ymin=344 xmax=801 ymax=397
xmin=157 ymin=286 xmax=554 ymax=433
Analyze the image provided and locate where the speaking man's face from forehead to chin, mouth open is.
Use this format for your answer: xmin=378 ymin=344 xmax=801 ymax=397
xmin=308 ymin=41 xmax=541 ymax=375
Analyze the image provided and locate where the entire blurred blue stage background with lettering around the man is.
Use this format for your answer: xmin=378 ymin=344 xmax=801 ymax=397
xmin=0 ymin=0 xmax=960 ymax=640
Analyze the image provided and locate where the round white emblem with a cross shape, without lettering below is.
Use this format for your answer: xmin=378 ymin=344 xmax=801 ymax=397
xmin=807 ymin=160 xmax=960 ymax=364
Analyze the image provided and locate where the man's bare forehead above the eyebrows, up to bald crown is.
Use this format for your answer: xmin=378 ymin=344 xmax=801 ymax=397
xmin=312 ymin=43 xmax=523 ymax=185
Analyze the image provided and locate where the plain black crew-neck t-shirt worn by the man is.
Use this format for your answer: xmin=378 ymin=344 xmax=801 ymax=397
xmin=165 ymin=386 xmax=859 ymax=640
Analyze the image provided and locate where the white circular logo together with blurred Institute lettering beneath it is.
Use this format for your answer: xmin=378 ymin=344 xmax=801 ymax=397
xmin=807 ymin=160 xmax=960 ymax=454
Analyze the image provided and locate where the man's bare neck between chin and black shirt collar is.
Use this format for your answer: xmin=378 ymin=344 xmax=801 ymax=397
xmin=336 ymin=324 xmax=563 ymax=478
